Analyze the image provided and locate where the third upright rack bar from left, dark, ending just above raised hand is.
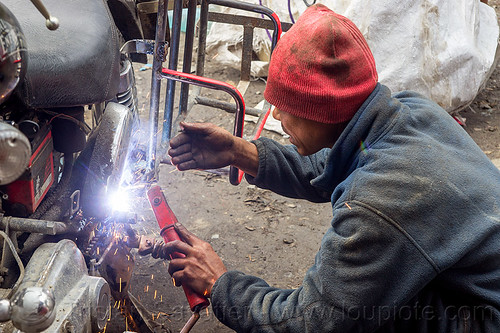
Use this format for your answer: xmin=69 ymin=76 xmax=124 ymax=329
xmin=179 ymin=0 xmax=197 ymax=118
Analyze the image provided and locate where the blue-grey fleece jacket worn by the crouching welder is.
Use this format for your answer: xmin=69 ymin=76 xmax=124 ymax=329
xmin=211 ymin=84 xmax=500 ymax=333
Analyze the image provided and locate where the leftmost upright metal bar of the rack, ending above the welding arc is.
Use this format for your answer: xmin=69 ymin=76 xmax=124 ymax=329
xmin=146 ymin=0 xmax=168 ymax=178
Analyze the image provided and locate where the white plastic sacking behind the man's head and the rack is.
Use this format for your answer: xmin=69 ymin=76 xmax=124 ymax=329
xmin=207 ymin=0 xmax=499 ymax=113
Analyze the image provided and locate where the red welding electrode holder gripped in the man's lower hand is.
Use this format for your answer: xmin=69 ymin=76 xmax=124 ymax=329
xmin=148 ymin=186 xmax=210 ymax=312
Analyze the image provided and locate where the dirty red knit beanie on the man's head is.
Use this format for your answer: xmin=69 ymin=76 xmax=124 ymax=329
xmin=264 ymin=4 xmax=378 ymax=124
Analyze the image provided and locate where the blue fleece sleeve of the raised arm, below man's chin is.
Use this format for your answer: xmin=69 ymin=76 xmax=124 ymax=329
xmin=246 ymin=138 xmax=331 ymax=202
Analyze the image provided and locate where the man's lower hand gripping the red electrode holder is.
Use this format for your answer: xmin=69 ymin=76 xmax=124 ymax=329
xmin=162 ymin=223 xmax=227 ymax=297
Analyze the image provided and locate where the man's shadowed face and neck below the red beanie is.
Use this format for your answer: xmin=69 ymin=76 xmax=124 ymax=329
xmin=273 ymin=108 xmax=347 ymax=156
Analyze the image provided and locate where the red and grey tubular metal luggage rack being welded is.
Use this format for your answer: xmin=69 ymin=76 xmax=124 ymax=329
xmin=124 ymin=0 xmax=292 ymax=185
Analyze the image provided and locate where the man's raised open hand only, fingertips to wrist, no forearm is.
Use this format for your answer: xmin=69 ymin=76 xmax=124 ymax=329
xmin=168 ymin=122 xmax=235 ymax=171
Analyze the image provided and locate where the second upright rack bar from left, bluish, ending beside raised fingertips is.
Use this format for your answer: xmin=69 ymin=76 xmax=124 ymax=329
xmin=161 ymin=0 xmax=182 ymax=146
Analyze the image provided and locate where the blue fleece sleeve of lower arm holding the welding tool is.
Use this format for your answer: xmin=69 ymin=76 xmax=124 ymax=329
xmin=211 ymin=201 xmax=437 ymax=333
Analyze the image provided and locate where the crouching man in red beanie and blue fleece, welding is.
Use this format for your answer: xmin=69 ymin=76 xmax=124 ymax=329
xmin=164 ymin=5 xmax=500 ymax=332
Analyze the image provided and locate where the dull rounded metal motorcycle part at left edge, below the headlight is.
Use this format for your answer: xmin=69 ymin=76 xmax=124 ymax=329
xmin=0 ymin=122 xmax=31 ymax=185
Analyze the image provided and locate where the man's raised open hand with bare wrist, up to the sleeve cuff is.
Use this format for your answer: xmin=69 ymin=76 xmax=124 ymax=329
xmin=168 ymin=122 xmax=259 ymax=177
